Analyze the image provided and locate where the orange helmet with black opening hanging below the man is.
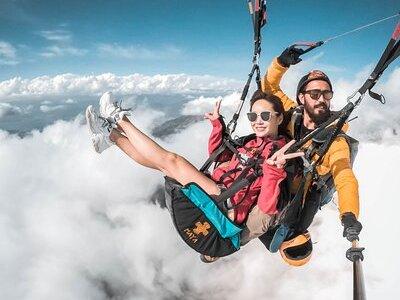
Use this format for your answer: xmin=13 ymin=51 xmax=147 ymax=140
xmin=279 ymin=231 xmax=312 ymax=267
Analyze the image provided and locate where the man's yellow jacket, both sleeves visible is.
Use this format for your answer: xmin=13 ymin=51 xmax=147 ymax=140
xmin=261 ymin=58 xmax=359 ymax=217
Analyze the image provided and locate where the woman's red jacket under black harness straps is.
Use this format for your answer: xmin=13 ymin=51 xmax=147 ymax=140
xmin=208 ymin=119 xmax=286 ymax=224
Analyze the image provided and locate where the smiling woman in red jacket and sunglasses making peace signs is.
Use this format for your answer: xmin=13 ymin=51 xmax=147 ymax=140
xmin=86 ymin=91 xmax=302 ymax=262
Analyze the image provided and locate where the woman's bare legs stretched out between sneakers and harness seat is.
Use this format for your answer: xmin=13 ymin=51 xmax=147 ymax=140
xmin=110 ymin=117 xmax=220 ymax=195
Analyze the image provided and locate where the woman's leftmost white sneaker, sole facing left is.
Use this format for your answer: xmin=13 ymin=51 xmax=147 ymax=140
xmin=86 ymin=105 xmax=114 ymax=153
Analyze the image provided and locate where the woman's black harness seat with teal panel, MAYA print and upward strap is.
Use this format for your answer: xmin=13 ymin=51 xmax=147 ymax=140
xmin=165 ymin=0 xmax=267 ymax=257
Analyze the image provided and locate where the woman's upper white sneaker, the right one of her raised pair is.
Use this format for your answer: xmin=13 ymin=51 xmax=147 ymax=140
xmin=99 ymin=92 xmax=130 ymax=128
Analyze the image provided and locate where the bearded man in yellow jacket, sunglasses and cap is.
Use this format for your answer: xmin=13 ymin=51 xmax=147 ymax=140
xmin=262 ymin=46 xmax=362 ymax=245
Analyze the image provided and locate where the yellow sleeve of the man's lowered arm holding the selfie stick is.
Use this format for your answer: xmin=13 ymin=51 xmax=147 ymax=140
xmin=328 ymin=137 xmax=359 ymax=218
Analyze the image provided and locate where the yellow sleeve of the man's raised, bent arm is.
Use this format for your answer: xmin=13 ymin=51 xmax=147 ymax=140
xmin=261 ymin=58 xmax=297 ymax=111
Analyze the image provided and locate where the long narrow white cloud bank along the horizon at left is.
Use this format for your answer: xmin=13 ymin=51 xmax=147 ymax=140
xmin=0 ymin=73 xmax=241 ymax=100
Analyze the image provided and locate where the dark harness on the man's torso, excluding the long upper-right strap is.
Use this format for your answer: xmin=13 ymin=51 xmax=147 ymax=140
xmin=259 ymin=106 xmax=358 ymax=252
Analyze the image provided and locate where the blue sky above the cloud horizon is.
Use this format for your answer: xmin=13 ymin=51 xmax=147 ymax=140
xmin=0 ymin=0 xmax=400 ymax=80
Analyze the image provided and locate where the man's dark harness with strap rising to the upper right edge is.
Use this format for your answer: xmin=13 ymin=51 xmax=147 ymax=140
xmin=259 ymin=19 xmax=400 ymax=252
